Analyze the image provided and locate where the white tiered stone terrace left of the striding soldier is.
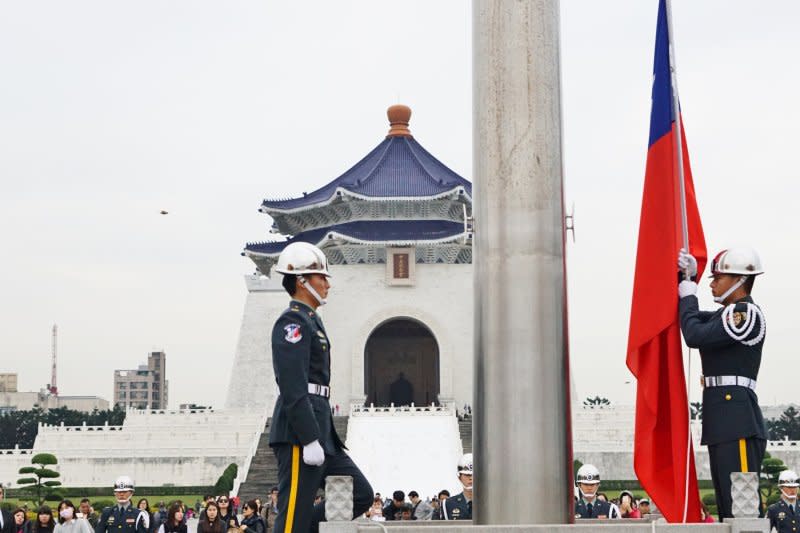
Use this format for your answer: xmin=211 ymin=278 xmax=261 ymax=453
xmin=0 ymin=410 xmax=265 ymax=487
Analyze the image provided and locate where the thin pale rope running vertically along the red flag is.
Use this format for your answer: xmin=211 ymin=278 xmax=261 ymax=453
xmin=665 ymin=0 xmax=692 ymax=523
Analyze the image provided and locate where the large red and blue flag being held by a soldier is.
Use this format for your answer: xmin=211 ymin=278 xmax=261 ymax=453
xmin=627 ymin=0 xmax=707 ymax=522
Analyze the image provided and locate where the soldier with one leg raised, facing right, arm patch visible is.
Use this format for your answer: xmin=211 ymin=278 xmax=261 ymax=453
xmin=269 ymin=242 xmax=372 ymax=533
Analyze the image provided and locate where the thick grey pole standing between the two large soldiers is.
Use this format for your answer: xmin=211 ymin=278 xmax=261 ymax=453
xmin=473 ymin=0 xmax=572 ymax=525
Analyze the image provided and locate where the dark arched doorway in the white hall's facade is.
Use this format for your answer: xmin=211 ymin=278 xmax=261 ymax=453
xmin=364 ymin=318 xmax=439 ymax=405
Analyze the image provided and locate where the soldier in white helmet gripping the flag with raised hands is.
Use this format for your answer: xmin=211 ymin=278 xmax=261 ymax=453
xmin=678 ymin=248 xmax=767 ymax=520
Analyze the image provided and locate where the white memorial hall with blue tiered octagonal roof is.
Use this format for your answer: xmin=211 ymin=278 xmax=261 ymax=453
xmin=227 ymin=105 xmax=473 ymax=420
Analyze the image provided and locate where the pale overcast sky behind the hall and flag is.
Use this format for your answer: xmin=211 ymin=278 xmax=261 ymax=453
xmin=0 ymin=0 xmax=800 ymax=407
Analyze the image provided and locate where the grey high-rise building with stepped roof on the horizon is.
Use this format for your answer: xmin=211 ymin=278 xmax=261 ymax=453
xmin=114 ymin=352 xmax=169 ymax=409
